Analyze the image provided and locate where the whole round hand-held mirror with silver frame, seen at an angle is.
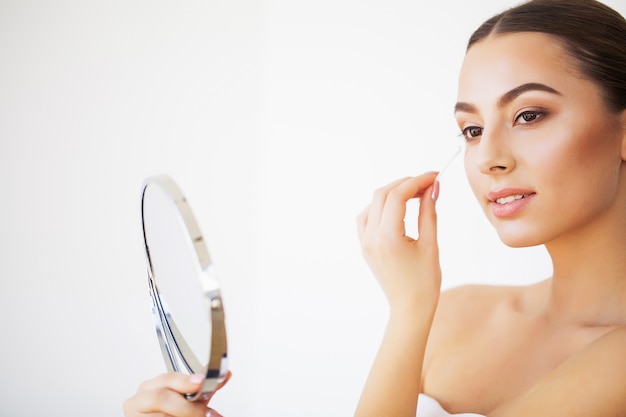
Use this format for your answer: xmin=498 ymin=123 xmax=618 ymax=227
xmin=141 ymin=176 xmax=227 ymax=401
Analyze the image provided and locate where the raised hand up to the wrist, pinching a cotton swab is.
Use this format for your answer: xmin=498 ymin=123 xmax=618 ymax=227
xmin=358 ymin=172 xmax=441 ymax=309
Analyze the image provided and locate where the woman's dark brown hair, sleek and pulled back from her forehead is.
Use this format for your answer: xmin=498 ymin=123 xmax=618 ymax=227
xmin=467 ymin=0 xmax=626 ymax=112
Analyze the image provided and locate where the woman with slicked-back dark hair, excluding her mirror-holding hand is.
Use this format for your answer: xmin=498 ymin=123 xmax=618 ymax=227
xmin=356 ymin=0 xmax=626 ymax=417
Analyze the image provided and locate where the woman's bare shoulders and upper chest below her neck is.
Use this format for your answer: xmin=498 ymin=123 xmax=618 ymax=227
xmin=422 ymin=281 xmax=626 ymax=417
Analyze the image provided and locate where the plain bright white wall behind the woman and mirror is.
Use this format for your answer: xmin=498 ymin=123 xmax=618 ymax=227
xmin=0 ymin=0 xmax=626 ymax=417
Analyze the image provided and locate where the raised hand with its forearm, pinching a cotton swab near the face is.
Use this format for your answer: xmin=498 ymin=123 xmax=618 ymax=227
xmin=355 ymin=172 xmax=441 ymax=417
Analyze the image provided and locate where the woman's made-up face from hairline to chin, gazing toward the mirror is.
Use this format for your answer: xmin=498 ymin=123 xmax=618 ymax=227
xmin=455 ymin=32 xmax=626 ymax=247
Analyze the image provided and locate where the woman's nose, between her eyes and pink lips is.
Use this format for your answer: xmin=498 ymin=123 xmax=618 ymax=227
xmin=474 ymin=129 xmax=515 ymax=175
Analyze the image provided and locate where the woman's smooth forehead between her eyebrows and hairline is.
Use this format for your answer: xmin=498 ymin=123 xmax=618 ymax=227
xmin=459 ymin=32 xmax=581 ymax=101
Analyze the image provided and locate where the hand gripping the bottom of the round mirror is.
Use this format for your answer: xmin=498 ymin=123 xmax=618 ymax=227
xmin=123 ymin=371 xmax=231 ymax=417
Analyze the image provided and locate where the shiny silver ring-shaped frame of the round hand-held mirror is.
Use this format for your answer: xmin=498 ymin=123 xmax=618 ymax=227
xmin=141 ymin=175 xmax=228 ymax=401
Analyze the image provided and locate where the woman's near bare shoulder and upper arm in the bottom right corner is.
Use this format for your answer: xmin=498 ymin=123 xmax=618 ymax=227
xmin=490 ymin=326 xmax=626 ymax=417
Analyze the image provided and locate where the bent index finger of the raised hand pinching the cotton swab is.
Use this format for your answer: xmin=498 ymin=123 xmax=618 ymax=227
xmin=380 ymin=173 xmax=436 ymax=237
